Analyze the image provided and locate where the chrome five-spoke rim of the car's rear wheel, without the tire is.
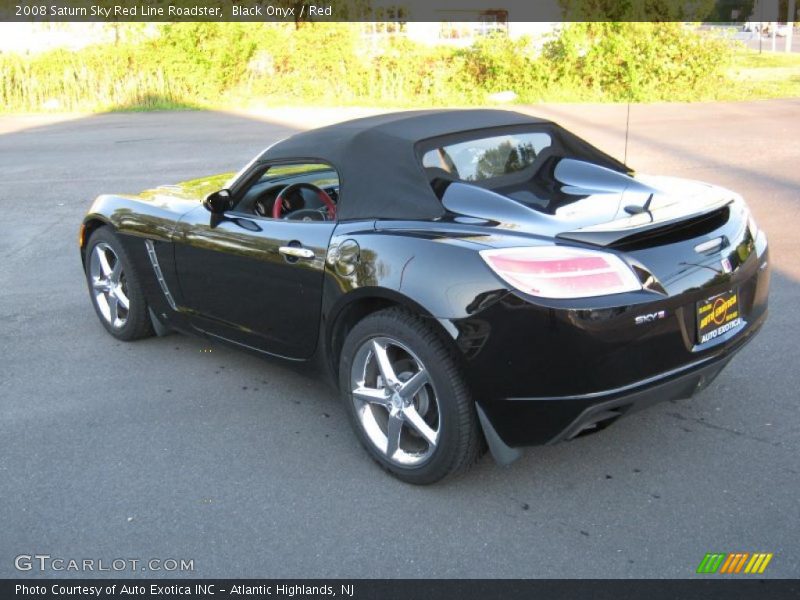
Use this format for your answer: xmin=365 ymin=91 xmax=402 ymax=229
xmin=350 ymin=337 xmax=441 ymax=466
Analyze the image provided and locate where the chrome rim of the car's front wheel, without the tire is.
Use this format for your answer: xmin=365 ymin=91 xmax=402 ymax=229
xmin=89 ymin=242 xmax=130 ymax=329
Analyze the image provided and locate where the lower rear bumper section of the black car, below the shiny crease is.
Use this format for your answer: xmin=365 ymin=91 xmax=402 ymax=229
xmin=478 ymin=311 xmax=767 ymax=448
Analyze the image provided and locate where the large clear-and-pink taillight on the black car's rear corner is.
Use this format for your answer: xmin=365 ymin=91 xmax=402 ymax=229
xmin=480 ymin=246 xmax=642 ymax=298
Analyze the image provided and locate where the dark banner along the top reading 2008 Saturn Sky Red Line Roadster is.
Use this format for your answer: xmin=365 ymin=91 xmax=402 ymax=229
xmin=0 ymin=0 xmax=778 ymax=24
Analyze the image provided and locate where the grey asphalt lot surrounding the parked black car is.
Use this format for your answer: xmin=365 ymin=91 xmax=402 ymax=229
xmin=0 ymin=99 xmax=800 ymax=578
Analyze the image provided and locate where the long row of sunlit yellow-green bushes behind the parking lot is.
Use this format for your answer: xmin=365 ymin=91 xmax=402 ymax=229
xmin=0 ymin=23 xmax=731 ymax=111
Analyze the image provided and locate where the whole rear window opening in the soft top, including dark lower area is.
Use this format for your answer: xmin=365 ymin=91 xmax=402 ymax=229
xmin=417 ymin=123 xmax=630 ymax=214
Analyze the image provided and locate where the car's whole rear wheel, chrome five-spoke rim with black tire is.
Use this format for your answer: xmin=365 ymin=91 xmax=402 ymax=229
xmin=339 ymin=309 xmax=482 ymax=484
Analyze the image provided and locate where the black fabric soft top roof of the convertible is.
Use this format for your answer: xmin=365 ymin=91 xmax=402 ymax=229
xmin=261 ymin=109 xmax=624 ymax=220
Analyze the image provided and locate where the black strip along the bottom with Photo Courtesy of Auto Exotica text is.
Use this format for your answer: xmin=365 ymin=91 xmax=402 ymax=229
xmin=0 ymin=576 xmax=800 ymax=600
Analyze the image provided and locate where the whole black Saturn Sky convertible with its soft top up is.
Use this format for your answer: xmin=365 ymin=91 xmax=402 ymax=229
xmin=80 ymin=110 xmax=769 ymax=484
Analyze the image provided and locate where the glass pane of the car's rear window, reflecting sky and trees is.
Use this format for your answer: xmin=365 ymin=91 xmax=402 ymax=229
xmin=422 ymin=132 xmax=553 ymax=181
